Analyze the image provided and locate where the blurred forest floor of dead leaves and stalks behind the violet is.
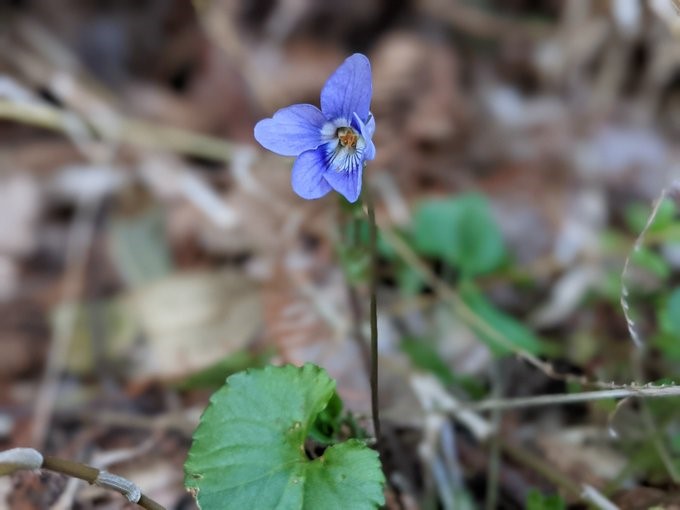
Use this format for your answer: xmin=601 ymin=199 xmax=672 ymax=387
xmin=0 ymin=0 xmax=680 ymax=510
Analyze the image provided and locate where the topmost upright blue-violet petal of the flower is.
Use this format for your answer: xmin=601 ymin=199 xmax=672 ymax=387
xmin=321 ymin=53 xmax=372 ymax=121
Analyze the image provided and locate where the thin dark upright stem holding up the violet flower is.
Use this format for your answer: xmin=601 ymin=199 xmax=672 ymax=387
xmin=366 ymin=192 xmax=380 ymax=441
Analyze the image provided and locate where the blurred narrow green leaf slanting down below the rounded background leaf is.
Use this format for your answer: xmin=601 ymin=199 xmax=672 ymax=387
xmin=460 ymin=282 xmax=544 ymax=356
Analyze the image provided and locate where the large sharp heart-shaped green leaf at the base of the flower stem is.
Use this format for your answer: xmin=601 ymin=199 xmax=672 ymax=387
xmin=184 ymin=364 xmax=385 ymax=510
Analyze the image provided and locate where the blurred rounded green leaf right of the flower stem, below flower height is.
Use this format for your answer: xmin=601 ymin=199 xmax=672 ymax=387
xmin=413 ymin=194 xmax=506 ymax=276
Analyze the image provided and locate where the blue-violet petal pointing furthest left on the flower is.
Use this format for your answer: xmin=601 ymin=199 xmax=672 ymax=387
xmin=255 ymin=104 xmax=326 ymax=156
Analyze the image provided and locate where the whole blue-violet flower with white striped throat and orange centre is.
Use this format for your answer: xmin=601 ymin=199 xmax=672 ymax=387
xmin=255 ymin=53 xmax=375 ymax=202
